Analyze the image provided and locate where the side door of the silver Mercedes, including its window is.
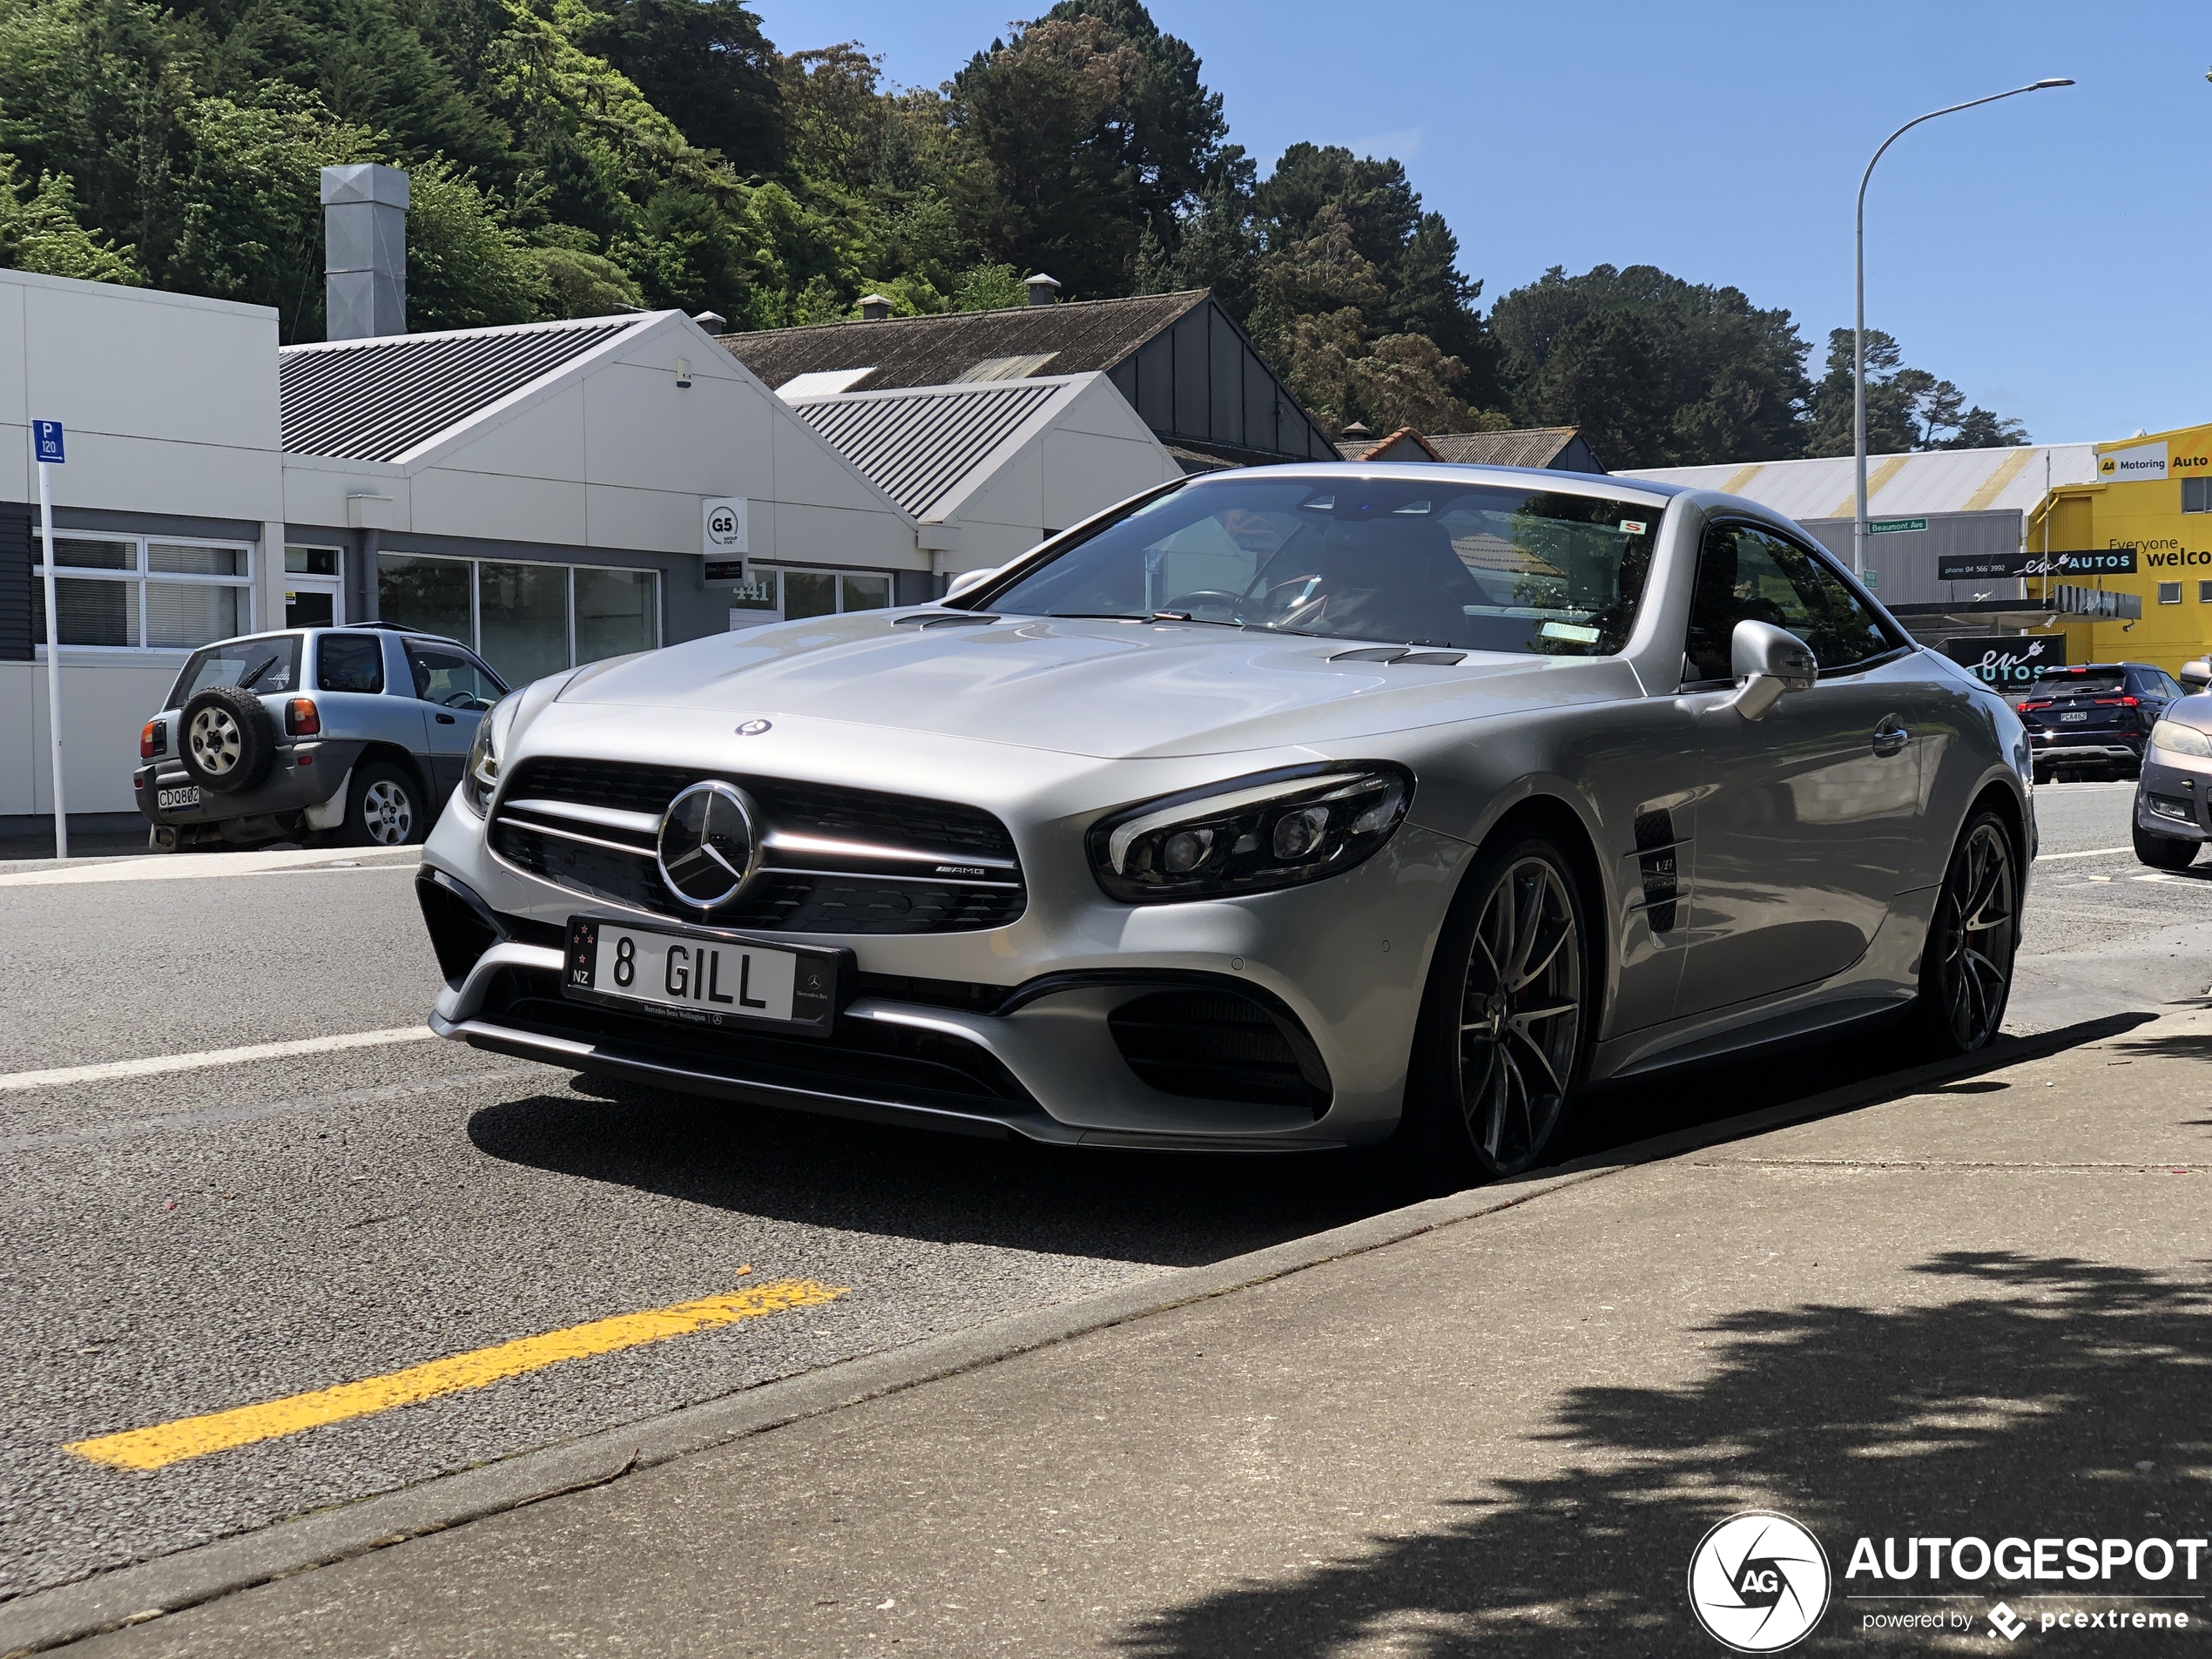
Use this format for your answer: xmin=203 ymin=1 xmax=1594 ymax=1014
xmin=1676 ymin=522 xmax=1926 ymax=1015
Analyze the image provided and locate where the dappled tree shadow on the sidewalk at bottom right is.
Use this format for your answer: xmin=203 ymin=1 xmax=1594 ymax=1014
xmin=1119 ymin=1252 xmax=2212 ymax=1659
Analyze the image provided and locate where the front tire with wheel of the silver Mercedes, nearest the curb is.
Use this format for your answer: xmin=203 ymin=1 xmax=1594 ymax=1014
xmin=1392 ymin=834 xmax=1597 ymax=1190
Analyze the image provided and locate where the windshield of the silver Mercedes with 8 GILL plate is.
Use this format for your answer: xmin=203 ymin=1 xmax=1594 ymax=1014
xmin=982 ymin=471 xmax=1663 ymax=657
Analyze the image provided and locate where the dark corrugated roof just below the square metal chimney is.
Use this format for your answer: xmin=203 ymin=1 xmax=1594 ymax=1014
xmin=277 ymin=316 xmax=646 ymax=460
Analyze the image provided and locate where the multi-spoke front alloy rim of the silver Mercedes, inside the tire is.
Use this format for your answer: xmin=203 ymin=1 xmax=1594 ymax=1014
xmin=1460 ymin=856 xmax=1581 ymax=1175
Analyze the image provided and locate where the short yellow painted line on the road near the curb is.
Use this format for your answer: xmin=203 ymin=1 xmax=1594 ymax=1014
xmin=69 ymin=1278 xmax=847 ymax=1469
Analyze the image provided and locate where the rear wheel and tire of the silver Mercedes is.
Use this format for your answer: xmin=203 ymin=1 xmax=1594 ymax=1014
xmin=1912 ymin=810 xmax=2020 ymax=1057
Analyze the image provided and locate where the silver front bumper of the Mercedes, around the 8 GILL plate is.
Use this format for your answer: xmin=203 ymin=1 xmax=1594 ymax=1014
xmin=418 ymin=812 xmax=1471 ymax=1150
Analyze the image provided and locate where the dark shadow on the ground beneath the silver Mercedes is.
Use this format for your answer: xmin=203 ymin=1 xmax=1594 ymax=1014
xmin=469 ymin=1015 xmax=2150 ymax=1267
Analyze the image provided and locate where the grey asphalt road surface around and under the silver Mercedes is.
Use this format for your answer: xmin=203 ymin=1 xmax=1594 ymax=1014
xmin=0 ymin=786 xmax=2212 ymax=1597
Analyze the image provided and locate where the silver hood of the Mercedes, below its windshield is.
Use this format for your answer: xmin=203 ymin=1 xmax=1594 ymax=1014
xmin=560 ymin=613 xmax=1642 ymax=759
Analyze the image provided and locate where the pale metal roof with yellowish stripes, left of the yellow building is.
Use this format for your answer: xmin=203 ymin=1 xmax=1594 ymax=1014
xmin=1615 ymin=445 xmax=2097 ymax=520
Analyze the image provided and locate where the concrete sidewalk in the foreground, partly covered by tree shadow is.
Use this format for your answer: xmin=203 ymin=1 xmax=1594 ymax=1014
xmin=47 ymin=1011 xmax=2212 ymax=1656
